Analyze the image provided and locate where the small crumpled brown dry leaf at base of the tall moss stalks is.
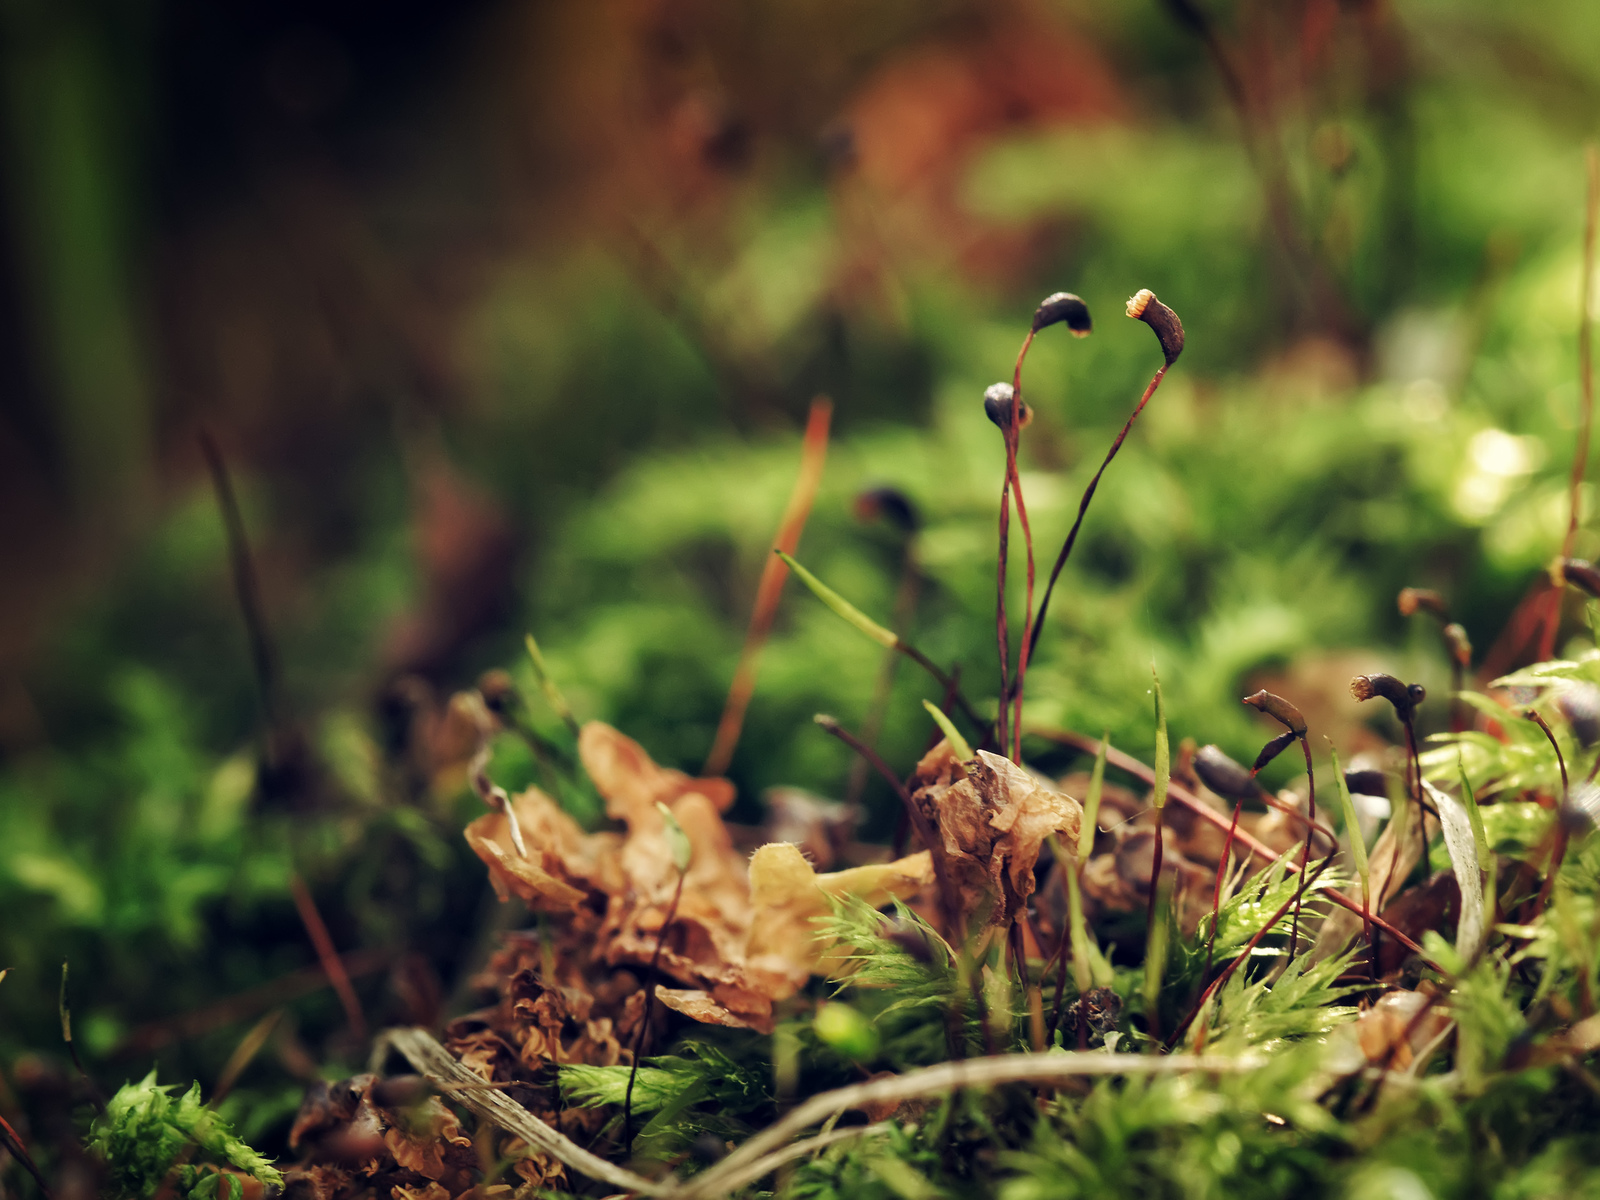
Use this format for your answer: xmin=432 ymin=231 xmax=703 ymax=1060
xmin=912 ymin=741 xmax=1083 ymax=925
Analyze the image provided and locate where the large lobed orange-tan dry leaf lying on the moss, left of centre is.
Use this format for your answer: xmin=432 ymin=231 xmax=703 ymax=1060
xmin=467 ymin=722 xmax=934 ymax=1036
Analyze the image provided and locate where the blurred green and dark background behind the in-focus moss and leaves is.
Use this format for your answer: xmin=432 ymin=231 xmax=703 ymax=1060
xmin=0 ymin=0 xmax=1600 ymax=1177
